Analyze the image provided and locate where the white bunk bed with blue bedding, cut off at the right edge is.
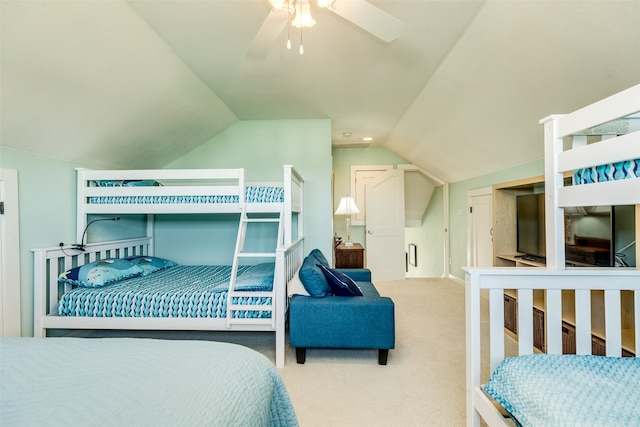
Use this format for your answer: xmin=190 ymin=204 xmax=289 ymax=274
xmin=465 ymin=85 xmax=640 ymax=426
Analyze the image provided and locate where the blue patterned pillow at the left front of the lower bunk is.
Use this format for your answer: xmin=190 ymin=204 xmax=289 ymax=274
xmin=58 ymin=258 xmax=143 ymax=288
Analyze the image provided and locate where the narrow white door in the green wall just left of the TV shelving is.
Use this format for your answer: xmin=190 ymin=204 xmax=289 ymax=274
xmin=467 ymin=188 xmax=493 ymax=267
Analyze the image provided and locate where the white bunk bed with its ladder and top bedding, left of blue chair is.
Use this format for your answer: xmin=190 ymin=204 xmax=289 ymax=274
xmin=33 ymin=166 xmax=304 ymax=367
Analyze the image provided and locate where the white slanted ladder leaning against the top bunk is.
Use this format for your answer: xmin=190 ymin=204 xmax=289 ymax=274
xmin=227 ymin=204 xmax=284 ymax=329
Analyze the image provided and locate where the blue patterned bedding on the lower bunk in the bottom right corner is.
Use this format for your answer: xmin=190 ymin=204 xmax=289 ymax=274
xmin=484 ymin=354 xmax=640 ymax=427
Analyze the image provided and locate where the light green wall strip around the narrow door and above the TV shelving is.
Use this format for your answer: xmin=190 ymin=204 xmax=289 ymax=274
xmin=449 ymin=159 xmax=544 ymax=280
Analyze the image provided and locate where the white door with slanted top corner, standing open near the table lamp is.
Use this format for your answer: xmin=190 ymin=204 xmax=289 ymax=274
xmin=365 ymin=170 xmax=405 ymax=281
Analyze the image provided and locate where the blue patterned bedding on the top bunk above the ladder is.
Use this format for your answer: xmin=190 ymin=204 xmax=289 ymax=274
xmin=88 ymin=185 xmax=284 ymax=205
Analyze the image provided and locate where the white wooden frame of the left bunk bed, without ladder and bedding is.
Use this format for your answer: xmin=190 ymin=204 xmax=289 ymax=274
xmin=33 ymin=165 xmax=304 ymax=368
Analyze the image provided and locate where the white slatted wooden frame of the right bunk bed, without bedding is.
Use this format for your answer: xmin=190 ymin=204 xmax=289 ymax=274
xmin=465 ymin=85 xmax=640 ymax=427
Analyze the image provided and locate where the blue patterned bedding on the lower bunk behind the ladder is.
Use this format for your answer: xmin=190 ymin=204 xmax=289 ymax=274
xmin=57 ymin=263 xmax=275 ymax=318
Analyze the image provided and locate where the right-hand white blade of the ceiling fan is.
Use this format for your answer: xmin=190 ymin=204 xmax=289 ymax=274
xmin=329 ymin=0 xmax=404 ymax=43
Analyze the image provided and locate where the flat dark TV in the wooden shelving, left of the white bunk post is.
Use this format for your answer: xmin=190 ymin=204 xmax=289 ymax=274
xmin=516 ymin=193 xmax=546 ymax=258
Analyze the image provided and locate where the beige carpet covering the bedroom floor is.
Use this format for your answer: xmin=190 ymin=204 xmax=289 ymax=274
xmin=67 ymin=279 xmax=508 ymax=427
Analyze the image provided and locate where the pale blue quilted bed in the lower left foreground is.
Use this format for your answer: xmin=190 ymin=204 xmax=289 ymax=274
xmin=0 ymin=338 xmax=298 ymax=427
